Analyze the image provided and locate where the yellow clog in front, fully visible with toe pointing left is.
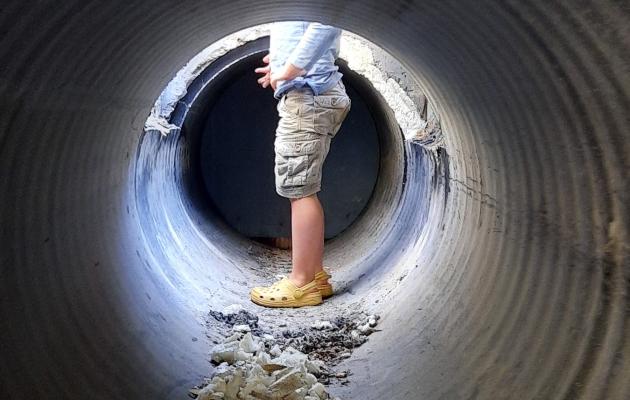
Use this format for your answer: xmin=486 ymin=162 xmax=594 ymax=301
xmin=250 ymin=278 xmax=323 ymax=308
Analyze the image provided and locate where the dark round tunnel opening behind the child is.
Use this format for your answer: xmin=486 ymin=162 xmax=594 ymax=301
xmin=175 ymin=39 xmax=386 ymax=247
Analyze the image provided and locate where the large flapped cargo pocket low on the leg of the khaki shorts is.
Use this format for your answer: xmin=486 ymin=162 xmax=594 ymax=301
xmin=276 ymin=140 xmax=321 ymax=187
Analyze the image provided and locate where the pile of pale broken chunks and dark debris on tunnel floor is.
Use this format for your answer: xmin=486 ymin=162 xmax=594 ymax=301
xmin=190 ymin=306 xmax=379 ymax=400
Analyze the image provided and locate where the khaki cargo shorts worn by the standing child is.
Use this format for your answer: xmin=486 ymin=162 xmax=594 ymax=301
xmin=274 ymin=81 xmax=350 ymax=199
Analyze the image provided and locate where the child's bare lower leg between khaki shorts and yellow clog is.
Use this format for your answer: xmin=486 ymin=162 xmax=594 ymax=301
xmin=289 ymin=194 xmax=324 ymax=287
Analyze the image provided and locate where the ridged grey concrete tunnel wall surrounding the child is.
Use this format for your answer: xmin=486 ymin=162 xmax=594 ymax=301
xmin=0 ymin=0 xmax=630 ymax=400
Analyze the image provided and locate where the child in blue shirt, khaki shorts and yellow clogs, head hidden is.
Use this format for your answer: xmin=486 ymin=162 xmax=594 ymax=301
xmin=251 ymin=22 xmax=350 ymax=307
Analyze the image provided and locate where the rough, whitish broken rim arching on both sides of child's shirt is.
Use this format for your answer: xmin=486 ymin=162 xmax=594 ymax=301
xmin=144 ymin=24 xmax=443 ymax=149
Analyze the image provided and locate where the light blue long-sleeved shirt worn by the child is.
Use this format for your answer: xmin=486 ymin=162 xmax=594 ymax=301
xmin=269 ymin=22 xmax=342 ymax=99
